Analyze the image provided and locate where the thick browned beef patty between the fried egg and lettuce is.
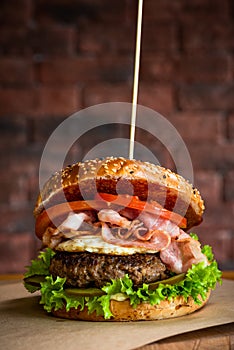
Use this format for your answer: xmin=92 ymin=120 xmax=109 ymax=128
xmin=50 ymin=252 xmax=169 ymax=288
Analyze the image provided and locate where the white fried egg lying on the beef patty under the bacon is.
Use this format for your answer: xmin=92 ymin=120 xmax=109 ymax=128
xmin=56 ymin=235 xmax=155 ymax=255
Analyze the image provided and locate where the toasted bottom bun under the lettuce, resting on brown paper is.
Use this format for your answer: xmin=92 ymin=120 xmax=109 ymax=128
xmin=52 ymin=292 xmax=210 ymax=321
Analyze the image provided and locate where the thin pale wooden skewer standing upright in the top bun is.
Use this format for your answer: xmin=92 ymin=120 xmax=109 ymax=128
xmin=129 ymin=0 xmax=143 ymax=159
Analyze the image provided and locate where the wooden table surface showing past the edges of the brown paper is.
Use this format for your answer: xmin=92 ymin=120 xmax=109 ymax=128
xmin=0 ymin=271 xmax=234 ymax=350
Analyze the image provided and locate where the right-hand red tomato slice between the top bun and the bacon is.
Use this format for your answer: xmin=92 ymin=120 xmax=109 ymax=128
xmin=96 ymin=193 xmax=187 ymax=228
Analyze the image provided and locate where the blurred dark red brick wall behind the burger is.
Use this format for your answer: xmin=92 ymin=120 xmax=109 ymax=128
xmin=0 ymin=0 xmax=234 ymax=273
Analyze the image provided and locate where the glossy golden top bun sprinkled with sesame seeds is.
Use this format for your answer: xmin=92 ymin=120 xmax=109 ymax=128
xmin=34 ymin=157 xmax=205 ymax=228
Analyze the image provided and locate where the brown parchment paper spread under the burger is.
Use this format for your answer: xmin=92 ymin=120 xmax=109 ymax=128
xmin=0 ymin=280 xmax=234 ymax=350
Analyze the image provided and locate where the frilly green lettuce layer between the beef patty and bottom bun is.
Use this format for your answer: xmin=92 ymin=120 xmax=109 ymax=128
xmin=25 ymin=246 xmax=221 ymax=319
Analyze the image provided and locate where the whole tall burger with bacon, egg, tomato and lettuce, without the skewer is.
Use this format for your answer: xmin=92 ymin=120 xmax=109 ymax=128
xmin=24 ymin=157 xmax=221 ymax=321
